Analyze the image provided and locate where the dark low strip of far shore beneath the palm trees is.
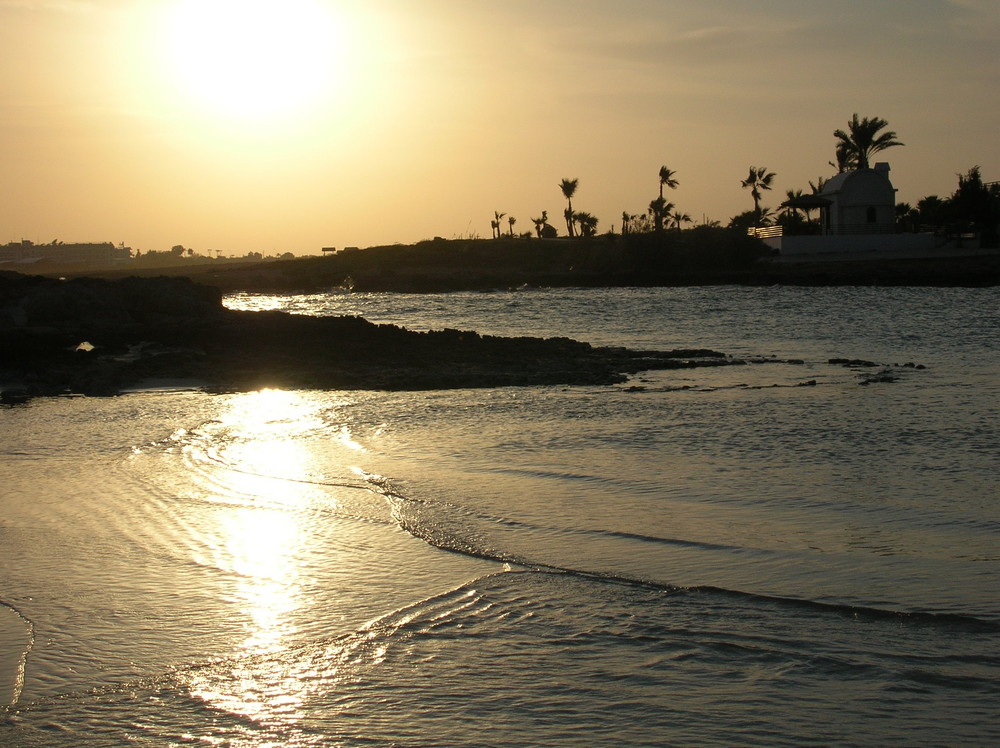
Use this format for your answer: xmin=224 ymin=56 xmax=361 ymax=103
xmin=17 ymin=235 xmax=1000 ymax=294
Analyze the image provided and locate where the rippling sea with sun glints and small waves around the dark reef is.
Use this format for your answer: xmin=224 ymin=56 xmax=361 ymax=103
xmin=0 ymin=287 xmax=1000 ymax=748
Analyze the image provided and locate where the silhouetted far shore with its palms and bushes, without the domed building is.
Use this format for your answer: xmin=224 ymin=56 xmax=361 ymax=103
xmin=7 ymin=114 xmax=1000 ymax=292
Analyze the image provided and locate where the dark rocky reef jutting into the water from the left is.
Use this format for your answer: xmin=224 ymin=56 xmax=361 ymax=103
xmin=0 ymin=273 xmax=741 ymax=403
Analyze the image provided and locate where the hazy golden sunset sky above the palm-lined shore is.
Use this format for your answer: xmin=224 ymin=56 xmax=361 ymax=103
xmin=0 ymin=0 xmax=1000 ymax=256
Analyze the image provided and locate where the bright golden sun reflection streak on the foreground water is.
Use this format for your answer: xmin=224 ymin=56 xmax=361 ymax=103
xmin=183 ymin=390 xmax=361 ymax=729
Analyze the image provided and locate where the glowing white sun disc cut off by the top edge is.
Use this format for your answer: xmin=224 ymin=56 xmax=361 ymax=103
xmin=161 ymin=0 xmax=348 ymax=120
